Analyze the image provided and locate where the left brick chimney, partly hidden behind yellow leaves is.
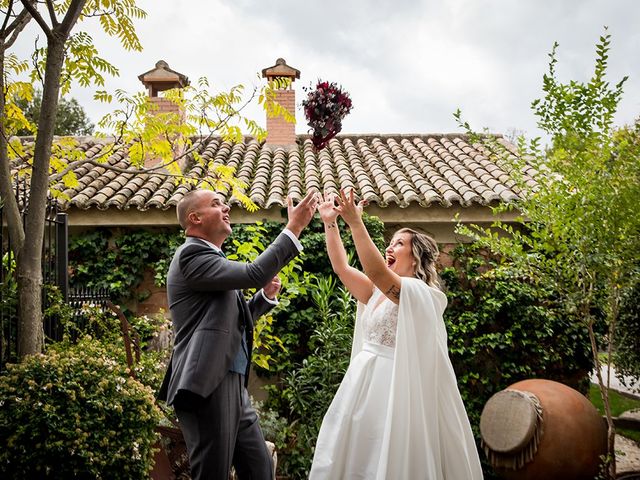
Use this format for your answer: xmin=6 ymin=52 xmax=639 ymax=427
xmin=138 ymin=60 xmax=189 ymax=168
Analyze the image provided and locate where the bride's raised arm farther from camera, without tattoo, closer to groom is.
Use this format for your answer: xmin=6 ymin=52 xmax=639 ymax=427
xmin=318 ymin=192 xmax=373 ymax=303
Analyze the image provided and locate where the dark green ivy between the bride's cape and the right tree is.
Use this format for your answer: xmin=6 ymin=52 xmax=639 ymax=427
xmin=441 ymin=245 xmax=593 ymax=432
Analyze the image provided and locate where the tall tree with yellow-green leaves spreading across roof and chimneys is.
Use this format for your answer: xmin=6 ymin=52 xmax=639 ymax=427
xmin=0 ymin=0 xmax=292 ymax=357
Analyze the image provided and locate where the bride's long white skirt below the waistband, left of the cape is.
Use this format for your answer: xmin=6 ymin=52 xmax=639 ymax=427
xmin=309 ymin=342 xmax=395 ymax=480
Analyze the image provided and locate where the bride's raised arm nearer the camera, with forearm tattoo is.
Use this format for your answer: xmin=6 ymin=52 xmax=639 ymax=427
xmin=338 ymin=190 xmax=401 ymax=304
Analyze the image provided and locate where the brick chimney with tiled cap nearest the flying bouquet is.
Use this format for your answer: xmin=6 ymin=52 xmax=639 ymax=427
xmin=262 ymin=58 xmax=300 ymax=145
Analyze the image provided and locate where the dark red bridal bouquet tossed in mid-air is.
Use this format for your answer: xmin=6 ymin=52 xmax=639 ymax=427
xmin=302 ymin=80 xmax=352 ymax=150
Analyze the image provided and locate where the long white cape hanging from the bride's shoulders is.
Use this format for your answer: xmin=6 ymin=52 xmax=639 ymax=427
xmin=351 ymin=277 xmax=483 ymax=480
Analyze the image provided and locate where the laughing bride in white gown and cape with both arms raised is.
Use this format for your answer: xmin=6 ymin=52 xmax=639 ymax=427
xmin=309 ymin=191 xmax=482 ymax=480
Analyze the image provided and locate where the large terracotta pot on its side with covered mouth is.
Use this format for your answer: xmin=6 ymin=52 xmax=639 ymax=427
xmin=480 ymin=379 xmax=607 ymax=480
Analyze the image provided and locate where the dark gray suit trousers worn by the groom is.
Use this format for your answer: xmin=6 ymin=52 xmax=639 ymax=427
xmin=174 ymin=372 xmax=273 ymax=480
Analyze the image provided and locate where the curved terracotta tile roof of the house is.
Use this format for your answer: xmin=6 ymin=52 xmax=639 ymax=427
xmin=16 ymin=134 xmax=535 ymax=210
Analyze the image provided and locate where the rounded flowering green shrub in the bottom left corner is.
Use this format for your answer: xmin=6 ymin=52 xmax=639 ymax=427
xmin=0 ymin=337 xmax=160 ymax=479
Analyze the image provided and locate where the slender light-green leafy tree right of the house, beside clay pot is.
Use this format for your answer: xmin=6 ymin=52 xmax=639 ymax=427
xmin=458 ymin=34 xmax=640 ymax=479
